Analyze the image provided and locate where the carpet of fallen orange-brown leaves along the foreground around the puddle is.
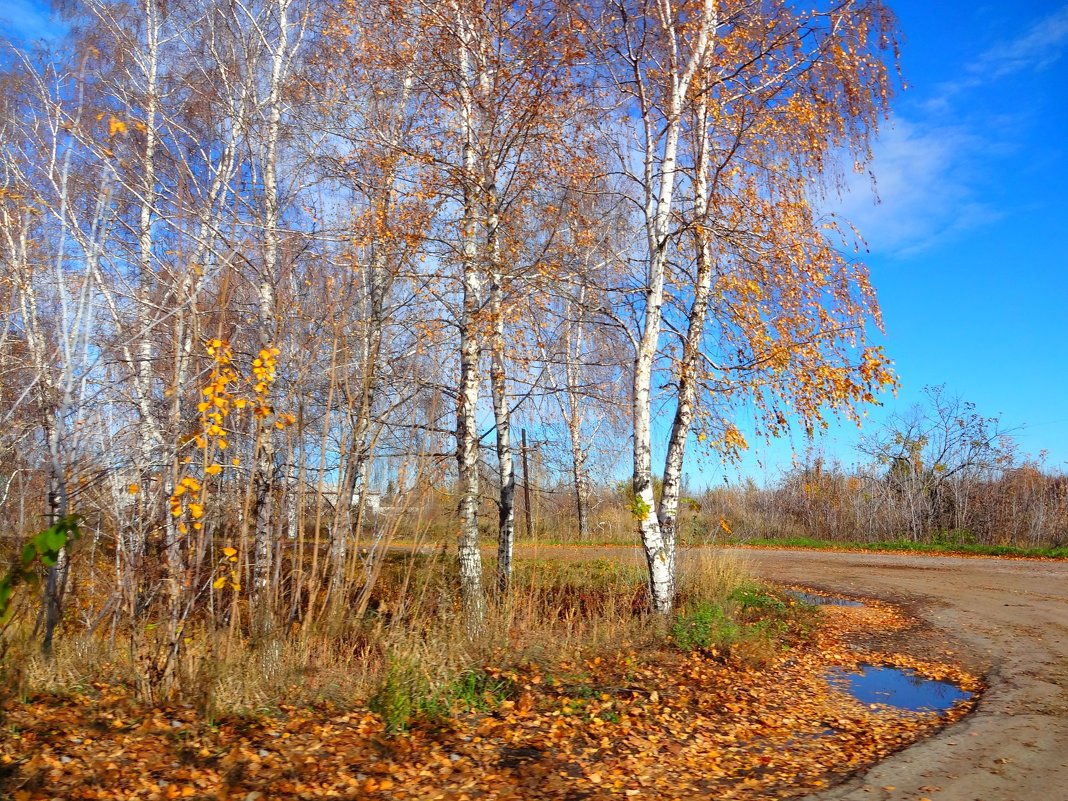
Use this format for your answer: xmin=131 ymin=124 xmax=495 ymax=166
xmin=0 ymin=602 xmax=981 ymax=801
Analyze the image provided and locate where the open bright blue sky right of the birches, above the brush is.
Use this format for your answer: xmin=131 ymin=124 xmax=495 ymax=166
xmin=8 ymin=0 xmax=1068 ymax=483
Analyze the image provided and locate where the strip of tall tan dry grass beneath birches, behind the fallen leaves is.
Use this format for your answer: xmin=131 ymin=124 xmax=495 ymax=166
xmin=5 ymin=552 xmax=747 ymax=718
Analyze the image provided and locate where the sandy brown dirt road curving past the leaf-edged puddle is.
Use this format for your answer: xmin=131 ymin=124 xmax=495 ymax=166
xmin=512 ymin=548 xmax=1068 ymax=801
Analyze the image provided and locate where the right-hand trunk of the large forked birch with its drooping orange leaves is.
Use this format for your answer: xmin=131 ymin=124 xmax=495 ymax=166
xmin=658 ymin=3 xmax=893 ymax=572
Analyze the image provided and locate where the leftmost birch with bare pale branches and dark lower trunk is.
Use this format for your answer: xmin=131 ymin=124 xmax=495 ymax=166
xmin=0 ymin=51 xmax=112 ymax=654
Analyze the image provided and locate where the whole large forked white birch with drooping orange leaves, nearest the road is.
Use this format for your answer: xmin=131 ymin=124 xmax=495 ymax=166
xmin=595 ymin=2 xmax=892 ymax=612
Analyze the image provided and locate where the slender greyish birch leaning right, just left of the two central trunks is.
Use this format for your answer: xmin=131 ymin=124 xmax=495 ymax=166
xmin=319 ymin=3 xmax=429 ymax=600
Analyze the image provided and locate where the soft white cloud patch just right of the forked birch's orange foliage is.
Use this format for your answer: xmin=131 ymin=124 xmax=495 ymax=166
xmin=834 ymin=119 xmax=999 ymax=257
